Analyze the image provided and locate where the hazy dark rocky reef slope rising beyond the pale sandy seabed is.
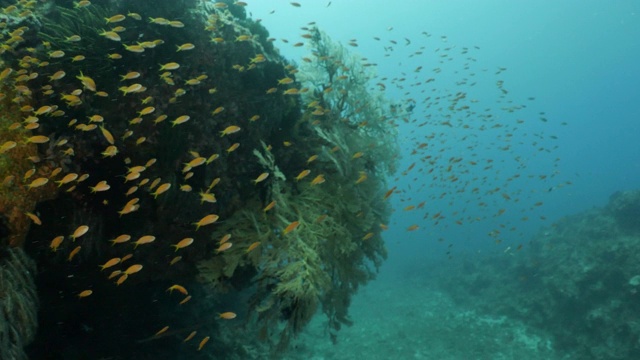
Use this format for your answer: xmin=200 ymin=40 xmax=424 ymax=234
xmin=442 ymin=190 xmax=640 ymax=359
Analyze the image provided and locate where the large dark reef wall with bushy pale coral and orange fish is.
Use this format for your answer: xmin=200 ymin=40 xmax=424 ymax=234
xmin=0 ymin=0 xmax=398 ymax=359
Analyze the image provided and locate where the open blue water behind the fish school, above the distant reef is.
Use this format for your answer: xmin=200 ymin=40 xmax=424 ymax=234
xmin=248 ymin=1 xmax=640 ymax=264
